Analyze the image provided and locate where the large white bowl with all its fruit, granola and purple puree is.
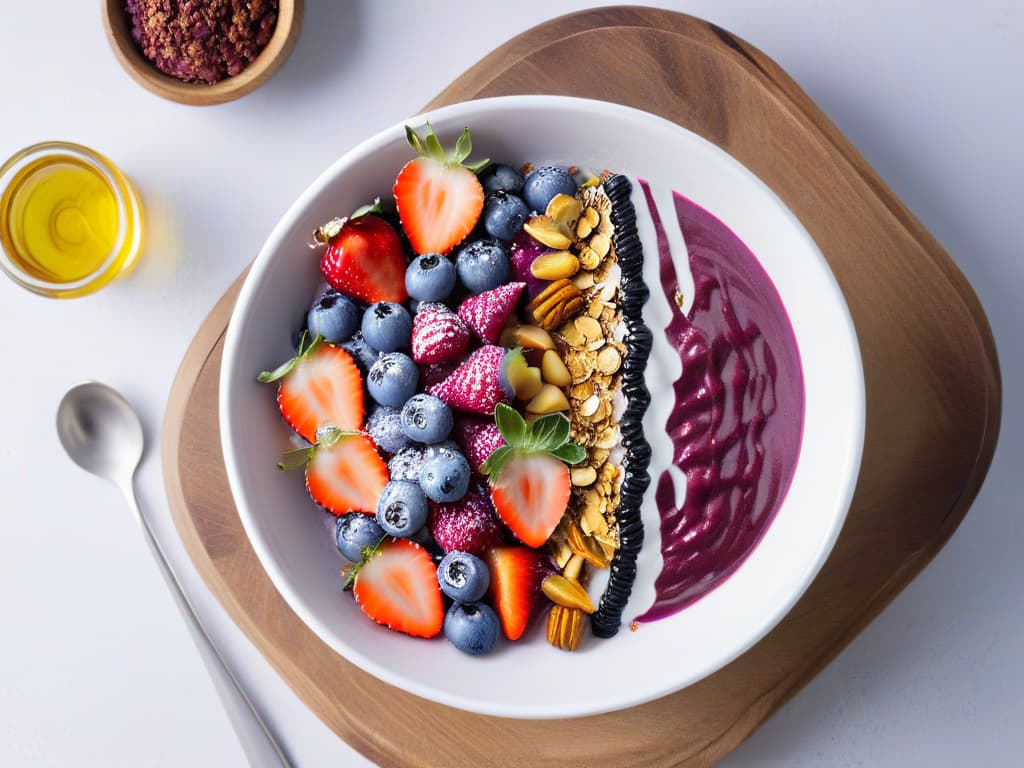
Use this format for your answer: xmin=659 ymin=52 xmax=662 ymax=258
xmin=220 ymin=96 xmax=864 ymax=718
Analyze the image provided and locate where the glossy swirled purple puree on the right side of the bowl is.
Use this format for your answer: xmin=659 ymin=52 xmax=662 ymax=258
xmin=638 ymin=181 xmax=804 ymax=622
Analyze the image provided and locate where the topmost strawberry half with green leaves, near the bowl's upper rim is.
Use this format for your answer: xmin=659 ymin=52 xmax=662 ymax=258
xmin=392 ymin=123 xmax=487 ymax=254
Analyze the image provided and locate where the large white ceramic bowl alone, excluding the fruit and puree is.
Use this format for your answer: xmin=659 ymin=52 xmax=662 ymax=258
xmin=220 ymin=96 xmax=864 ymax=718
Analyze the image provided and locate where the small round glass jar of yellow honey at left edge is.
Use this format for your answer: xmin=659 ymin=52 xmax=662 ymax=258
xmin=0 ymin=141 xmax=142 ymax=299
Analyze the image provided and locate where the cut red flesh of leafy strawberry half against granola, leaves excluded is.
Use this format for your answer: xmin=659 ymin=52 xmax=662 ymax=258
xmin=490 ymin=454 xmax=571 ymax=547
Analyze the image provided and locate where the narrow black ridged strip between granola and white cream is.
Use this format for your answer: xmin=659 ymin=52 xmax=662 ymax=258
xmin=591 ymin=174 xmax=652 ymax=638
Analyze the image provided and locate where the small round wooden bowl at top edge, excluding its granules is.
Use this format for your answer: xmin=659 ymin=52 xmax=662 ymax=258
xmin=103 ymin=0 xmax=303 ymax=106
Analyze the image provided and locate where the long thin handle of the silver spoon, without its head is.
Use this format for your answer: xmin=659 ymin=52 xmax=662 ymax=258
xmin=123 ymin=481 xmax=291 ymax=768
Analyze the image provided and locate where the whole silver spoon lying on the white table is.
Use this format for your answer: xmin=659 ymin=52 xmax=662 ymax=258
xmin=57 ymin=381 xmax=290 ymax=768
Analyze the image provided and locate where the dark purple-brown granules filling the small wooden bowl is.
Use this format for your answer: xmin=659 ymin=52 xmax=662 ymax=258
xmin=125 ymin=0 xmax=279 ymax=85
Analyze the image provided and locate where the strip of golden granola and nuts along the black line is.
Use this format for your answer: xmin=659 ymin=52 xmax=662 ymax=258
xmin=526 ymin=179 xmax=627 ymax=650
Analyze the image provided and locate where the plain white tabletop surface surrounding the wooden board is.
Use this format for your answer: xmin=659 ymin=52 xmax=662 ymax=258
xmin=0 ymin=0 xmax=1024 ymax=768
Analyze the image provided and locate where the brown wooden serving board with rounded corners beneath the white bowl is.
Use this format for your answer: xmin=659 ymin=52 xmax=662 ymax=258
xmin=163 ymin=7 xmax=1000 ymax=768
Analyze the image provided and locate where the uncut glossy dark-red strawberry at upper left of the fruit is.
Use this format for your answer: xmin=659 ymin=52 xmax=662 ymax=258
xmin=317 ymin=213 xmax=409 ymax=304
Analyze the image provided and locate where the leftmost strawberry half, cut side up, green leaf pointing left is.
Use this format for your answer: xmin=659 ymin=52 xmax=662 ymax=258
xmin=259 ymin=342 xmax=364 ymax=442
